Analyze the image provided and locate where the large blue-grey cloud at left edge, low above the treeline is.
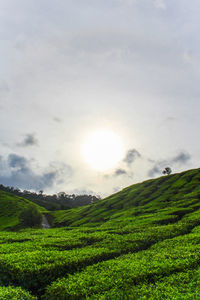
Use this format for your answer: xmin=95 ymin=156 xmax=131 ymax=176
xmin=0 ymin=154 xmax=72 ymax=191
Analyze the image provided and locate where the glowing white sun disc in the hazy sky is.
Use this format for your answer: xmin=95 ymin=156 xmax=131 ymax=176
xmin=82 ymin=129 xmax=124 ymax=171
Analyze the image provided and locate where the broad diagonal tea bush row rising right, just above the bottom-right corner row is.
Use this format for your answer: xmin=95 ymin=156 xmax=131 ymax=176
xmin=44 ymin=235 xmax=200 ymax=300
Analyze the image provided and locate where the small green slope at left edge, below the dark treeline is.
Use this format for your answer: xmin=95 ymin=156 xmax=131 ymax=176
xmin=0 ymin=190 xmax=46 ymax=230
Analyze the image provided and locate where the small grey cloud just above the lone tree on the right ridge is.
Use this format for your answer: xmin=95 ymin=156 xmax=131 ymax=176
xmin=148 ymin=151 xmax=191 ymax=177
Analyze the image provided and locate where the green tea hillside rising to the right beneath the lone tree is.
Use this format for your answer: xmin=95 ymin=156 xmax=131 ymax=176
xmin=52 ymin=169 xmax=200 ymax=226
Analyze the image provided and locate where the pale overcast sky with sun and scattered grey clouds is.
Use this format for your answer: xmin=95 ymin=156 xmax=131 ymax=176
xmin=0 ymin=0 xmax=200 ymax=197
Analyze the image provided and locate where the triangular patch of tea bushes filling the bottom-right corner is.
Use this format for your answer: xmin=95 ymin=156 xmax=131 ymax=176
xmin=91 ymin=269 xmax=200 ymax=300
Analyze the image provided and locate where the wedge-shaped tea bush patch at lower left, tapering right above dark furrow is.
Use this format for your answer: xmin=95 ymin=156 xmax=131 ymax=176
xmin=0 ymin=247 xmax=117 ymax=293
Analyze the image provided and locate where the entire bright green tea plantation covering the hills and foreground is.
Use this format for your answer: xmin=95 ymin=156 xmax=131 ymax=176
xmin=0 ymin=169 xmax=200 ymax=300
